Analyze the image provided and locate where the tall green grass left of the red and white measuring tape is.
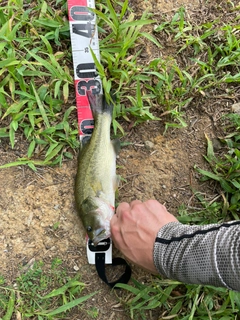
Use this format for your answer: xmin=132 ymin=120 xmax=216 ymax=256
xmin=0 ymin=0 xmax=78 ymax=170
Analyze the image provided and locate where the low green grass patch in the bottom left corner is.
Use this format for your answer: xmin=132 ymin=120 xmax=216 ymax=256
xmin=0 ymin=259 xmax=96 ymax=320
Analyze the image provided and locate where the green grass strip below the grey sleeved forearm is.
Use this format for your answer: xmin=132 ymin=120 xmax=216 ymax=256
xmin=115 ymin=278 xmax=240 ymax=320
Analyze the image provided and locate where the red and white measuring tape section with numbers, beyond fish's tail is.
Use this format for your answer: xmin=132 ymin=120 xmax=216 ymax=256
xmin=68 ymin=0 xmax=102 ymax=139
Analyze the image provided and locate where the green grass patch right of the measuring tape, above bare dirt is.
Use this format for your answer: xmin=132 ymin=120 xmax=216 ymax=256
xmin=96 ymin=1 xmax=240 ymax=132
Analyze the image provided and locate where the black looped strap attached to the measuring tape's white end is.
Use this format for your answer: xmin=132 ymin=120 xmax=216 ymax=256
xmin=95 ymin=252 xmax=132 ymax=288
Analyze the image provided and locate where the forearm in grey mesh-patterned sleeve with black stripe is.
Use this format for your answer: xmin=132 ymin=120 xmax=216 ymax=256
xmin=154 ymin=221 xmax=240 ymax=291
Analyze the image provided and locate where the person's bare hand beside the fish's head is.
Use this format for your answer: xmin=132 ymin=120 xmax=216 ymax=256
xmin=110 ymin=200 xmax=177 ymax=273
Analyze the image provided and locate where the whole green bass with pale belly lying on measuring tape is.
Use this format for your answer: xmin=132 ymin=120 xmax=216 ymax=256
xmin=74 ymin=92 xmax=120 ymax=246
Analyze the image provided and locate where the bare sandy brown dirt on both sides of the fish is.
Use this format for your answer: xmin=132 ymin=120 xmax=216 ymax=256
xmin=0 ymin=0 xmax=236 ymax=320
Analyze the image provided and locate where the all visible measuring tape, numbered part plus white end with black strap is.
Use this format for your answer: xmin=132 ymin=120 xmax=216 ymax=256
xmin=68 ymin=0 xmax=131 ymax=287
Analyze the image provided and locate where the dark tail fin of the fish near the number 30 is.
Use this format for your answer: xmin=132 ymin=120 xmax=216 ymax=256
xmin=87 ymin=91 xmax=113 ymax=118
